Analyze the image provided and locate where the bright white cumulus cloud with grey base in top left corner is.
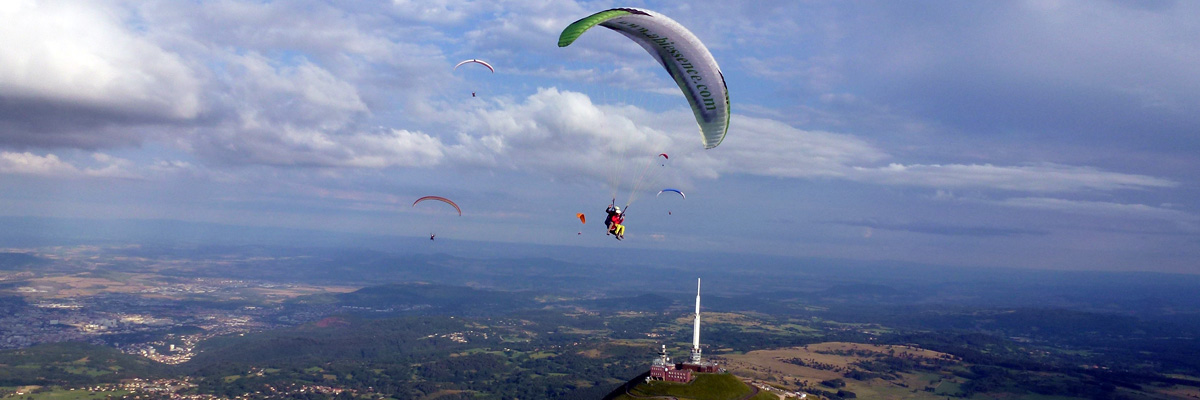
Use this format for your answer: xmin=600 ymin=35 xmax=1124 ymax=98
xmin=0 ymin=0 xmax=203 ymax=145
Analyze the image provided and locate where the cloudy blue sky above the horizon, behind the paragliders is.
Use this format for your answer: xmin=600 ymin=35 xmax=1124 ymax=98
xmin=0 ymin=0 xmax=1200 ymax=273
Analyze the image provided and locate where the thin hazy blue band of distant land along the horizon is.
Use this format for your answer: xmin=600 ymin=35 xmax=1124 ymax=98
xmin=0 ymin=216 xmax=1200 ymax=278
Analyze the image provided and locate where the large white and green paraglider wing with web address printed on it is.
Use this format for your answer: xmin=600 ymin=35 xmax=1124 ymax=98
xmin=558 ymin=8 xmax=730 ymax=149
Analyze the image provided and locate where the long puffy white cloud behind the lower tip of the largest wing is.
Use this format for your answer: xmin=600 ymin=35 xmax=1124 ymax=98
xmin=432 ymin=89 xmax=884 ymax=181
